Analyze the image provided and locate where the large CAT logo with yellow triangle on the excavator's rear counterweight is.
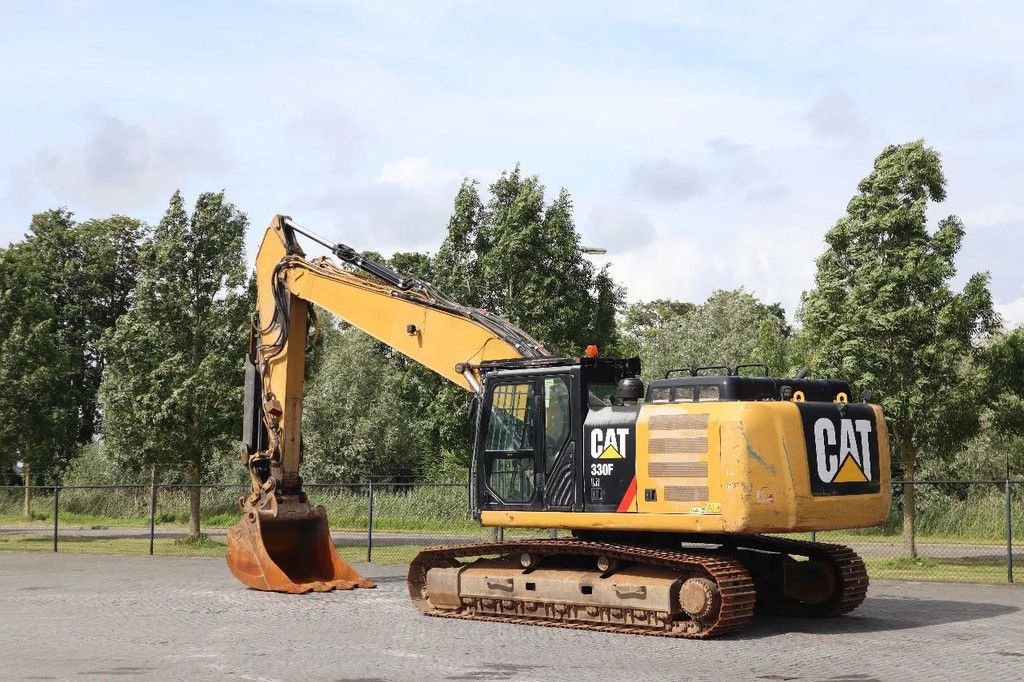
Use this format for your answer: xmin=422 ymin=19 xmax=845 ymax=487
xmin=814 ymin=417 xmax=872 ymax=483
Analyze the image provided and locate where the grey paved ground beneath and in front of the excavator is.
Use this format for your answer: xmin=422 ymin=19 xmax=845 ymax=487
xmin=0 ymin=553 xmax=1024 ymax=682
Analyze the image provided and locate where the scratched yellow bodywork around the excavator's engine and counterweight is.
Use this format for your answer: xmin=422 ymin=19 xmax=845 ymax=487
xmin=481 ymin=401 xmax=891 ymax=534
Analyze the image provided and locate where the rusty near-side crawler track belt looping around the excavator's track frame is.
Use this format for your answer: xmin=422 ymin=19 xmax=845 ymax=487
xmin=409 ymin=539 xmax=757 ymax=638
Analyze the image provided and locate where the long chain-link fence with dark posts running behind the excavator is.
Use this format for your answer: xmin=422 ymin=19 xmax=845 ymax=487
xmin=0 ymin=480 xmax=1024 ymax=583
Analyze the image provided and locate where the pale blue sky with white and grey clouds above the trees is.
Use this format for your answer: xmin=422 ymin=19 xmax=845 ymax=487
xmin=0 ymin=0 xmax=1024 ymax=325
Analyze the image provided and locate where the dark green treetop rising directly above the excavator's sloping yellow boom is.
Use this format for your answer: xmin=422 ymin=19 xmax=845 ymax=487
xmin=433 ymin=166 xmax=624 ymax=355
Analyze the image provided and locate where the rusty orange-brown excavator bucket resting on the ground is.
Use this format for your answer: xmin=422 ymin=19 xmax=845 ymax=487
xmin=227 ymin=507 xmax=376 ymax=594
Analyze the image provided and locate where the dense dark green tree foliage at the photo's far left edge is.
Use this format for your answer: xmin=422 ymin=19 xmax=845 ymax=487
xmin=0 ymin=209 xmax=144 ymax=474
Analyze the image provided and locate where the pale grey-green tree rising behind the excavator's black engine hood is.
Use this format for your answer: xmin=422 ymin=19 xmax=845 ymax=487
xmin=627 ymin=289 xmax=790 ymax=380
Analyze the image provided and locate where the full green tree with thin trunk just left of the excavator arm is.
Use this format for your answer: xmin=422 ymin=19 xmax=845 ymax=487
xmin=100 ymin=191 xmax=250 ymax=538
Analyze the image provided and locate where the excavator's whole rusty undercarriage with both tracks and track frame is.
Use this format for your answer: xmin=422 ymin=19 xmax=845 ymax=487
xmin=409 ymin=531 xmax=867 ymax=638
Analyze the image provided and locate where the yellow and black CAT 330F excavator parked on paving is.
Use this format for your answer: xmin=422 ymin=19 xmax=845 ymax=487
xmin=227 ymin=216 xmax=891 ymax=638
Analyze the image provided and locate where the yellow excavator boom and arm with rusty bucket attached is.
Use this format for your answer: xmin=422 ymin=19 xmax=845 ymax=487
xmin=227 ymin=216 xmax=549 ymax=593
